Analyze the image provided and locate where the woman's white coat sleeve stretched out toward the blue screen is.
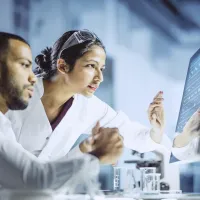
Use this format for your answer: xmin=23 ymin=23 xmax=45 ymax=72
xmin=83 ymin=97 xmax=172 ymax=153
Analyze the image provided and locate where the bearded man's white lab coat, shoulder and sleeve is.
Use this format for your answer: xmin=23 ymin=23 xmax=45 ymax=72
xmin=0 ymin=112 xmax=99 ymax=191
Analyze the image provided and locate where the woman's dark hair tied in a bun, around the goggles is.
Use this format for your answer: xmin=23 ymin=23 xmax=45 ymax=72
xmin=35 ymin=31 xmax=105 ymax=80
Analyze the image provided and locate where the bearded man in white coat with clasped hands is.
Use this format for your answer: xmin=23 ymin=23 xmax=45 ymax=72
xmin=0 ymin=32 xmax=122 ymax=189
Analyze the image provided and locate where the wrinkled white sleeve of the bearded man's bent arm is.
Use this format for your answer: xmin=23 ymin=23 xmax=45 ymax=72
xmin=0 ymin=135 xmax=98 ymax=189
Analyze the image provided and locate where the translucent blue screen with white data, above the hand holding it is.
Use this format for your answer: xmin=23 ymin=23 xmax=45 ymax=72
xmin=176 ymin=49 xmax=200 ymax=133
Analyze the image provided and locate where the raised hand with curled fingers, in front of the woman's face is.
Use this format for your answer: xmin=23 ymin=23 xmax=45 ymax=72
xmin=148 ymin=91 xmax=165 ymax=143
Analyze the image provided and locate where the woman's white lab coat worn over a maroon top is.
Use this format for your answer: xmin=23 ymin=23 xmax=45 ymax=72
xmin=7 ymin=79 xmax=171 ymax=160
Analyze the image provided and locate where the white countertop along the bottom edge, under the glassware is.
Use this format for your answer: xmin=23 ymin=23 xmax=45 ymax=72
xmin=0 ymin=190 xmax=200 ymax=200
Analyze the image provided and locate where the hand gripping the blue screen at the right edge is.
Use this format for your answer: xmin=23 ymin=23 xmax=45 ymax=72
xmin=173 ymin=109 xmax=200 ymax=148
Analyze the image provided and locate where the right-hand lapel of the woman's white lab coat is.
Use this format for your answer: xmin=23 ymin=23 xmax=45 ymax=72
xmin=39 ymin=96 xmax=83 ymax=160
